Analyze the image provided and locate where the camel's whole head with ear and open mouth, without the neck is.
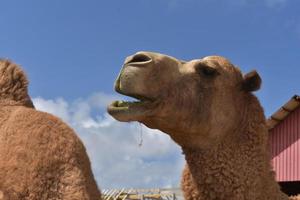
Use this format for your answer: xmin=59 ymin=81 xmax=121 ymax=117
xmin=108 ymin=52 xmax=261 ymax=147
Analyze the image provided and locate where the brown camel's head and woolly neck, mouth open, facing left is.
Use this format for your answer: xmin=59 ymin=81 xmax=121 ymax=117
xmin=108 ymin=52 xmax=296 ymax=200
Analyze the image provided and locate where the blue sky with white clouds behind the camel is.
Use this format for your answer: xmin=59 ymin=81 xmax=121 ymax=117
xmin=0 ymin=0 xmax=300 ymax=187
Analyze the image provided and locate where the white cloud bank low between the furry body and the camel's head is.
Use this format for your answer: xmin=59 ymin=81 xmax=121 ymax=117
xmin=33 ymin=93 xmax=184 ymax=188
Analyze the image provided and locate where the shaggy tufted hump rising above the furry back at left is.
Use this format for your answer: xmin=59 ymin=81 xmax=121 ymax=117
xmin=0 ymin=59 xmax=32 ymax=107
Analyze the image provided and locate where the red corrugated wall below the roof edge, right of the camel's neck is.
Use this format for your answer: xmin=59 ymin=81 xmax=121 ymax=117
xmin=270 ymin=108 xmax=300 ymax=181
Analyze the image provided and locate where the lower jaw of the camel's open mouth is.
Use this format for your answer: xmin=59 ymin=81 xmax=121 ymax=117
xmin=107 ymin=101 xmax=149 ymax=122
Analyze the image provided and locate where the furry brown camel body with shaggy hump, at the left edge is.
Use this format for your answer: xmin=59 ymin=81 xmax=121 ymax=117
xmin=0 ymin=60 xmax=100 ymax=200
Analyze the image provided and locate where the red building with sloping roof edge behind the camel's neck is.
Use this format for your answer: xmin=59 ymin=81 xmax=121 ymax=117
xmin=267 ymin=95 xmax=300 ymax=194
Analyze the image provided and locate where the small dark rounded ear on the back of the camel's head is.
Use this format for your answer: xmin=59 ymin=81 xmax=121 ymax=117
xmin=242 ymin=70 xmax=261 ymax=92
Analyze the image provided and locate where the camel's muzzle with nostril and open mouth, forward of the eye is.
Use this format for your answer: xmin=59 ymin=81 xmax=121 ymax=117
xmin=108 ymin=52 xmax=182 ymax=122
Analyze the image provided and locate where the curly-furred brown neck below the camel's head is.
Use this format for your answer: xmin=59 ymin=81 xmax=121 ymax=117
xmin=182 ymin=116 xmax=286 ymax=200
